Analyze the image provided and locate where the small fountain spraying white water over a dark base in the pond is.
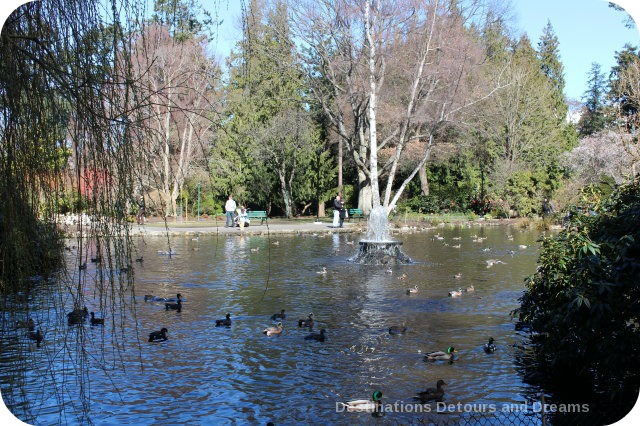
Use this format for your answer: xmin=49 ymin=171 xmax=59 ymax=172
xmin=350 ymin=206 xmax=411 ymax=265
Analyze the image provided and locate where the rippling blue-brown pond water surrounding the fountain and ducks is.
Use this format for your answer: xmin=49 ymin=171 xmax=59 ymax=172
xmin=0 ymin=227 xmax=539 ymax=425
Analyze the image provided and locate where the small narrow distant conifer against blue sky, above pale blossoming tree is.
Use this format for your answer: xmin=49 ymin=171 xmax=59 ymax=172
xmin=578 ymin=62 xmax=607 ymax=136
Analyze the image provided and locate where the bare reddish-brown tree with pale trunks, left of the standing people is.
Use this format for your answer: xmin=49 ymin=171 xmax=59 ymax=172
xmin=129 ymin=24 xmax=219 ymax=215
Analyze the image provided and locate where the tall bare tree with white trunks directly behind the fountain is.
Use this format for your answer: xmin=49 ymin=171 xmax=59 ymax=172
xmin=294 ymin=0 xmax=508 ymax=211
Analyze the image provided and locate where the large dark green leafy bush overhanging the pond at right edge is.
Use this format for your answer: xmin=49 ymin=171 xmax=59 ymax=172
xmin=515 ymin=176 xmax=640 ymax=416
